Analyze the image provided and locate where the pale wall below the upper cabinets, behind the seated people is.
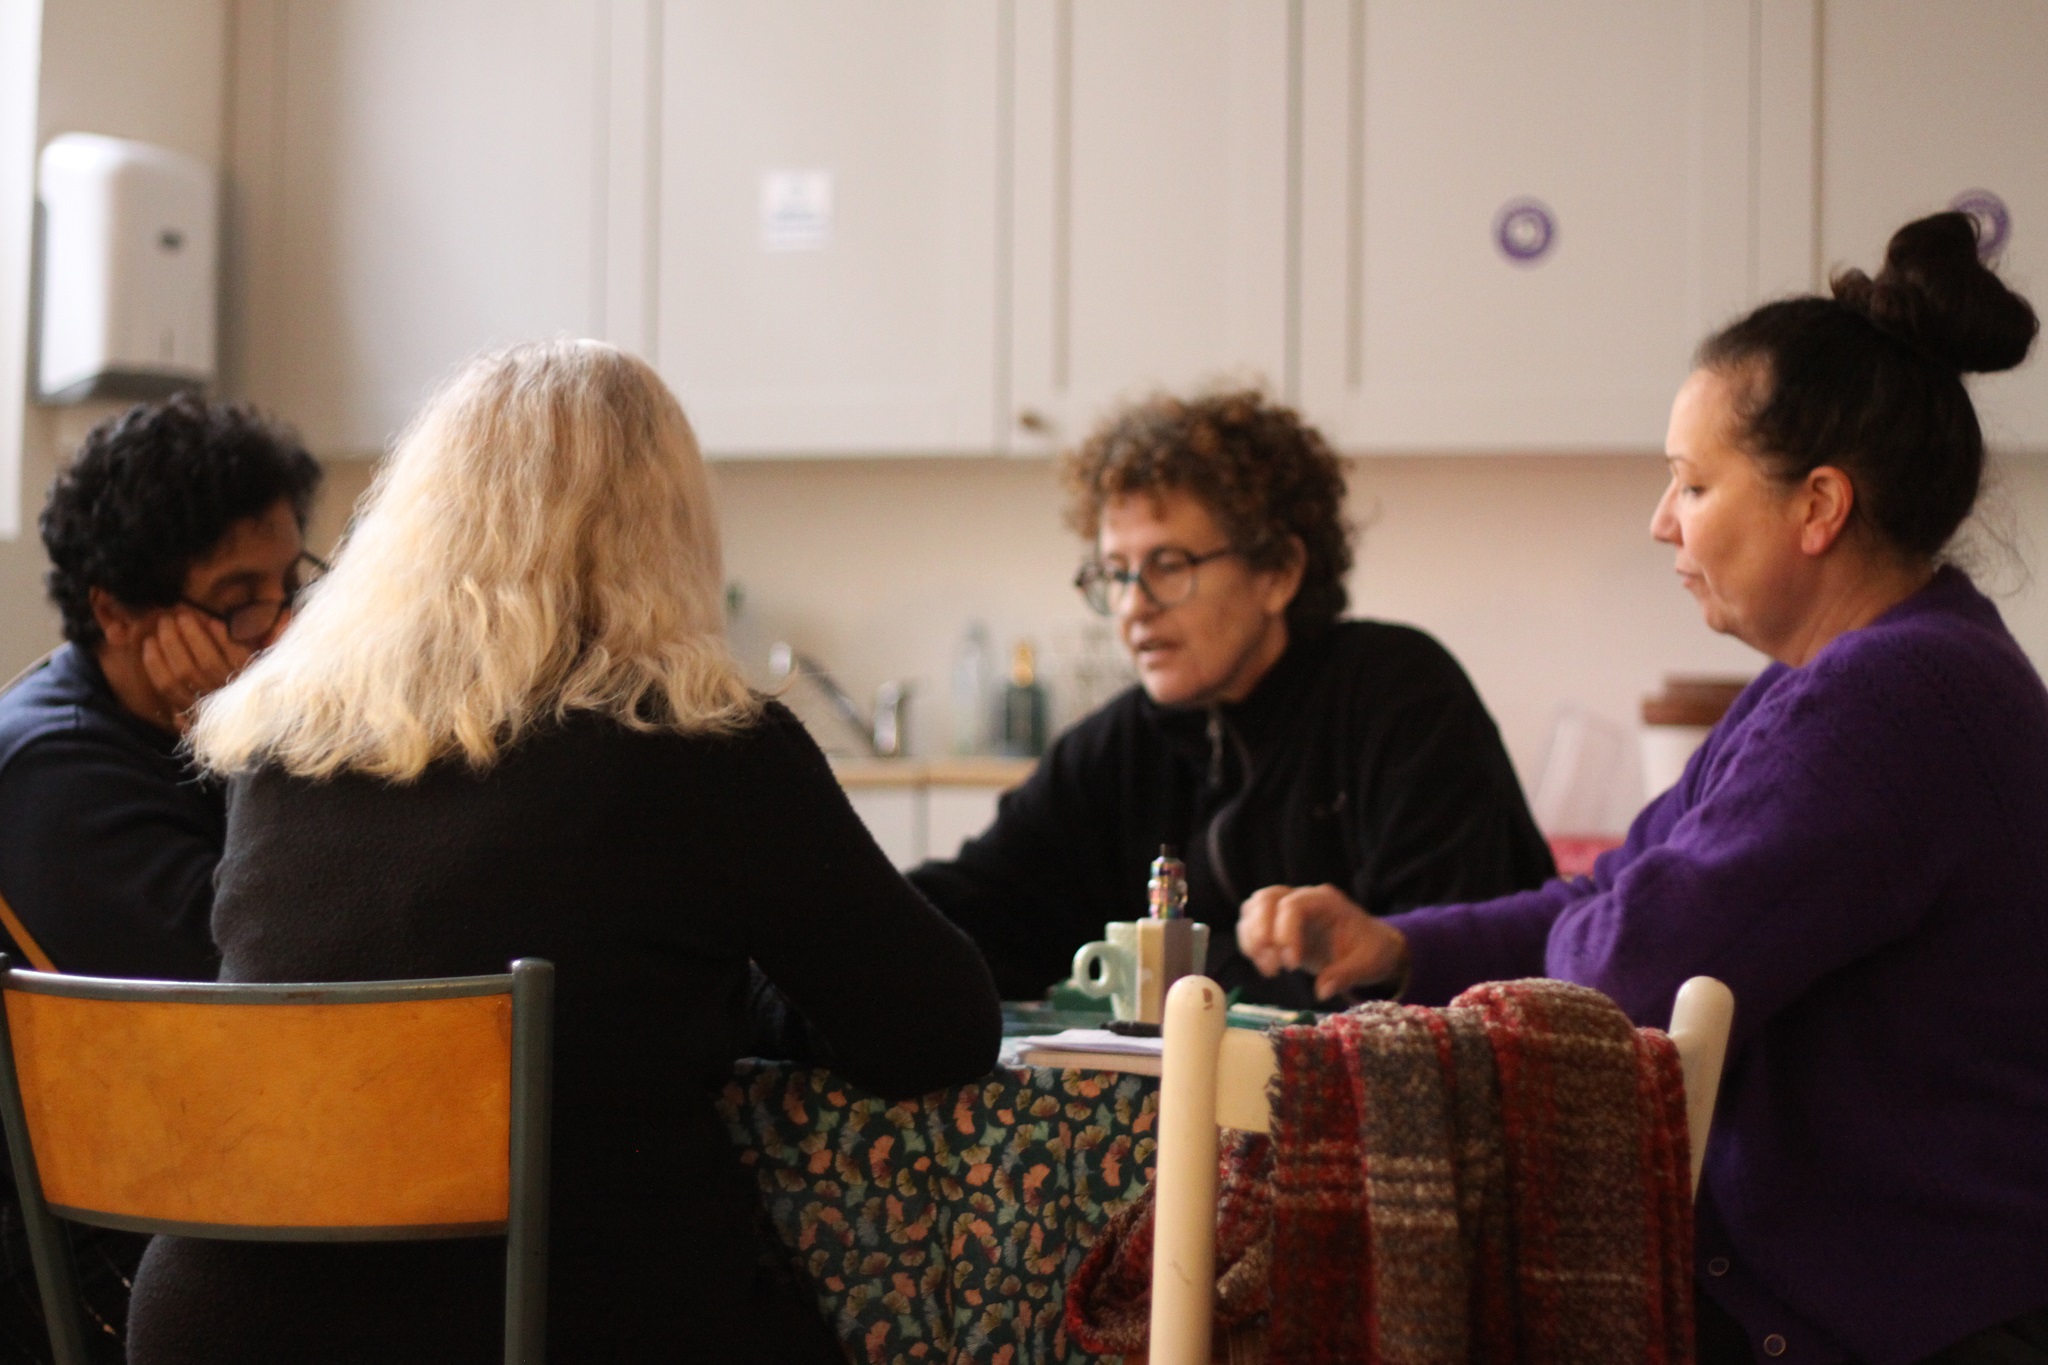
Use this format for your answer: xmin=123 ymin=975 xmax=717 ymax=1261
xmin=692 ymin=454 xmax=2048 ymax=825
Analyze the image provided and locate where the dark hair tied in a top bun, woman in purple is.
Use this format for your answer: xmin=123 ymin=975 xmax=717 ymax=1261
xmin=1698 ymin=213 xmax=2040 ymax=561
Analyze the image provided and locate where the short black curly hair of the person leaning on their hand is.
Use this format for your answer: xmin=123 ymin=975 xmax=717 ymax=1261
xmin=37 ymin=393 xmax=319 ymax=649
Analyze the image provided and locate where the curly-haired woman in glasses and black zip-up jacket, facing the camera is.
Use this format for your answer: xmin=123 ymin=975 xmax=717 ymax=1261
xmin=911 ymin=393 xmax=1552 ymax=1007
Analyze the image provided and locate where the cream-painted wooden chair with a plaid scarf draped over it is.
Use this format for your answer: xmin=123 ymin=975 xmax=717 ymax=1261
xmin=1147 ymin=976 xmax=1735 ymax=1365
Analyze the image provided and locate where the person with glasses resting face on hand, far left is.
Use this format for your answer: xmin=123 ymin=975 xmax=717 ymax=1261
xmin=0 ymin=393 xmax=319 ymax=1361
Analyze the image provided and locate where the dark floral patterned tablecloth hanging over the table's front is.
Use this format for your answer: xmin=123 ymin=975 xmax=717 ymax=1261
xmin=719 ymin=1062 xmax=1159 ymax=1365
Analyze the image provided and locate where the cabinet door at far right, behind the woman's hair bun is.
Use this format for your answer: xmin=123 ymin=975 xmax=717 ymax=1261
xmin=1821 ymin=0 xmax=2048 ymax=450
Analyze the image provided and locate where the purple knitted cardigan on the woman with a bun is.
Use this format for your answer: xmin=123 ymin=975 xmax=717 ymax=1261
xmin=1397 ymin=569 xmax=2048 ymax=1365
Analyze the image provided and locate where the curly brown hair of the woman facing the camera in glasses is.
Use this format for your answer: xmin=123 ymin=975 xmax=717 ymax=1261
xmin=1061 ymin=389 xmax=1352 ymax=639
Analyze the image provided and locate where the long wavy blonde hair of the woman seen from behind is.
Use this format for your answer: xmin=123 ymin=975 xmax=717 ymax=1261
xmin=190 ymin=342 xmax=760 ymax=782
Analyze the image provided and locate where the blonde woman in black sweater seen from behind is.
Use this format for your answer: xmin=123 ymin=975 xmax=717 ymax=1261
xmin=131 ymin=342 xmax=999 ymax=1365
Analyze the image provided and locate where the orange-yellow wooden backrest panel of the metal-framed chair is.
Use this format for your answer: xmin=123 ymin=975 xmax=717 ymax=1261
xmin=6 ymin=990 xmax=512 ymax=1236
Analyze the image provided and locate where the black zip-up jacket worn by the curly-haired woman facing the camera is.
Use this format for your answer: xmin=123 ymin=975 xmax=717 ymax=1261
xmin=911 ymin=620 xmax=1554 ymax=1009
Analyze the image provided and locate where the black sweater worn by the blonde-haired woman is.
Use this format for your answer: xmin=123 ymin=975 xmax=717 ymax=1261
xmin=131 ymin=704 xmax=1001 ymax=1365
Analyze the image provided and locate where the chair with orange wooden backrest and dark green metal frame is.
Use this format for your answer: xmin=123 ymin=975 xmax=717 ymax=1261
xmin=0 ymin=958 xmax=555 ymax=1365
